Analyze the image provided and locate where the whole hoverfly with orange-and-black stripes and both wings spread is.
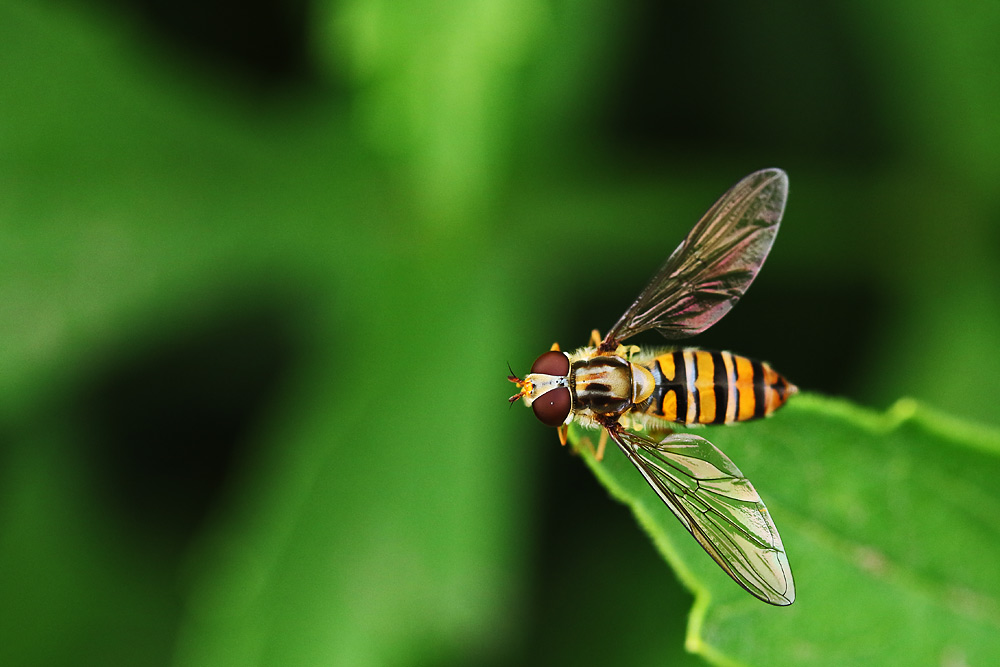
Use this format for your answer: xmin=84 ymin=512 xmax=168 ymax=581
xmin=508 ymin=169 xmax=798 ymax=605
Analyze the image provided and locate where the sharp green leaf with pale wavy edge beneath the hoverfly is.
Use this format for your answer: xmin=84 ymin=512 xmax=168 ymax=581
xmin=570 ymin=394 xmax=1000 ymax=665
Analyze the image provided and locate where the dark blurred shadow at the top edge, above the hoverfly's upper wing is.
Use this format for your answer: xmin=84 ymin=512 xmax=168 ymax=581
xmin=599 ymin=0 xmax=893 ymax=167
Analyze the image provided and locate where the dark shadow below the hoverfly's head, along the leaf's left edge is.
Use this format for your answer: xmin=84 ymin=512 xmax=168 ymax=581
xmin=476 ymin=434 xmax=696 ymax=665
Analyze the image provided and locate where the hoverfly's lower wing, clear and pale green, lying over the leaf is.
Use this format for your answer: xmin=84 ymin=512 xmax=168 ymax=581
xmin=608 ymin=427 xmax=795 ymax=605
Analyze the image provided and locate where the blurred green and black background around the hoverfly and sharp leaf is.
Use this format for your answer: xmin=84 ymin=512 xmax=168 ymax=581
xmin=0 ymin=0 xmax=1000 ymax=666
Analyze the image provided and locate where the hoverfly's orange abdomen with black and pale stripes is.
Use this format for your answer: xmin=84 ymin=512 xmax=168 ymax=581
xmin=641 ymin=348 xmax=797 ymax=424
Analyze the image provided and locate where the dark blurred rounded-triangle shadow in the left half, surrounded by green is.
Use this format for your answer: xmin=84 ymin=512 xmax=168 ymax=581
xmin=73 ymin=296 xmax=306 ymax=550
